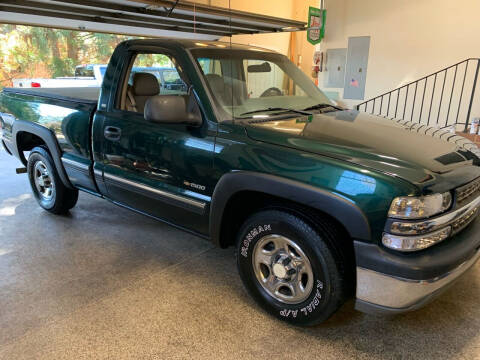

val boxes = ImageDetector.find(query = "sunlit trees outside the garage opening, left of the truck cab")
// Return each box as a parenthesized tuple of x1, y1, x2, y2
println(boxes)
(0, 24, 135, 88)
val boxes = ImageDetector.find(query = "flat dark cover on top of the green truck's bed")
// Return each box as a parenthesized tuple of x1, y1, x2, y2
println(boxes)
(3, 87, 100, 104)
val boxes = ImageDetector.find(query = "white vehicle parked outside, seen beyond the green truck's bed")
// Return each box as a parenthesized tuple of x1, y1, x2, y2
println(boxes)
(13, 64, 107, 88)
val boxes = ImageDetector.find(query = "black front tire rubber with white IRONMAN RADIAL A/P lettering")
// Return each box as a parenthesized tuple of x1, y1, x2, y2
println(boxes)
(237, 210, 348, 326)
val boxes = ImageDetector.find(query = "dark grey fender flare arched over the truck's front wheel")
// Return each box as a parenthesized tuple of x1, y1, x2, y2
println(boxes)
(210, 171, 371, 246)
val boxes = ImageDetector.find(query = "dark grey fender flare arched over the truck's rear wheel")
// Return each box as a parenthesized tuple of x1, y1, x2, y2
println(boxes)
(12, 120, 73, 189)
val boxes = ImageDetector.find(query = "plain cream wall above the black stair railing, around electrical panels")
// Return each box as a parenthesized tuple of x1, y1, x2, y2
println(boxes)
(319, 0, 480, 106)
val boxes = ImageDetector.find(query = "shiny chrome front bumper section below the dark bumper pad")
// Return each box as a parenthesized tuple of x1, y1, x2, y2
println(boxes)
(355, 249, 480, 313)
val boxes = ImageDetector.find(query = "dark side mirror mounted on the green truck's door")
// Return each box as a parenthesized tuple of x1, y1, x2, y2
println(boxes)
(143, 94, 202, 126)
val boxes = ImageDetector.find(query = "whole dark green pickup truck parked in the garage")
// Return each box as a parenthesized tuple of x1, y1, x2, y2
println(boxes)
(0, 39, 480, 325)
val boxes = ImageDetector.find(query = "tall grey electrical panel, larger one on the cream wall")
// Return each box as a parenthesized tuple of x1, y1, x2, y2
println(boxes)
(343, 36, 370, 100)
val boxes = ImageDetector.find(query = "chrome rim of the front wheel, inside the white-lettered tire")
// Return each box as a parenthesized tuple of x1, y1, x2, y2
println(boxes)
(252, 235, 314, 304)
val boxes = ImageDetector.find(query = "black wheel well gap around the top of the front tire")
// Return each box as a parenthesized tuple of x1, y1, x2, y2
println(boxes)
(220, 191, 356, 291)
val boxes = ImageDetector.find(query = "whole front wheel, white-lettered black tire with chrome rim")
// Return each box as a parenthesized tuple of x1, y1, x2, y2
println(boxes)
(237, 210, 345, 326)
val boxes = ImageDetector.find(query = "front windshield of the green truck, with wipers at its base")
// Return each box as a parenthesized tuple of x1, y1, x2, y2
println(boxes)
(192, 48, 332, 120)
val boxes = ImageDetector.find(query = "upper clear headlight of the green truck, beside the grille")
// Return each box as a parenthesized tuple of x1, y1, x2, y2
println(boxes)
(388, 192, 452, 219)
